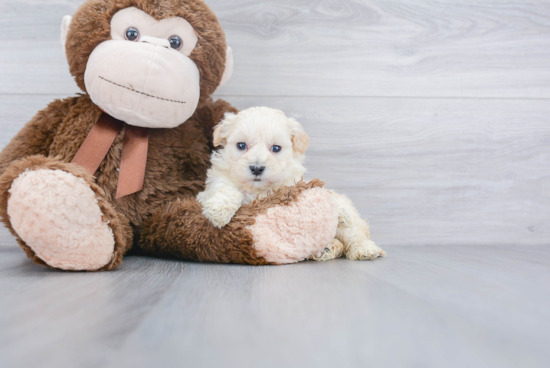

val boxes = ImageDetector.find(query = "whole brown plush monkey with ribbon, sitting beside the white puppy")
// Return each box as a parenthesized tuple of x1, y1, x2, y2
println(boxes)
(0, 0, 337, 271)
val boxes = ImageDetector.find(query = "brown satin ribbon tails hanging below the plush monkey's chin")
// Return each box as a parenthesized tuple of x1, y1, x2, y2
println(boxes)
(72, 113, 149, 199)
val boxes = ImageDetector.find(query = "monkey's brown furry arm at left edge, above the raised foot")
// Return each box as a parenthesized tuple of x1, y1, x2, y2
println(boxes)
(0, 97, 78, 175)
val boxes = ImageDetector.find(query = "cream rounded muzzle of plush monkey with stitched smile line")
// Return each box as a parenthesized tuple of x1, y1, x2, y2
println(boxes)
(84, 40, 200, 128)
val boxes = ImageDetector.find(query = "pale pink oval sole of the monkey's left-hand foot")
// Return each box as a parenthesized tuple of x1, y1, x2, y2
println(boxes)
(7, 169, 115, 271)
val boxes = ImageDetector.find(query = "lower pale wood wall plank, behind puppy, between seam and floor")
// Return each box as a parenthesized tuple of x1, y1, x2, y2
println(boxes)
(0, 96, 550, 246)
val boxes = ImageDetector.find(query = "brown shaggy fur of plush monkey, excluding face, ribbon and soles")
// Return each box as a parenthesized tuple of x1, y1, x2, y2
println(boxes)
(0, 0, 332, 270)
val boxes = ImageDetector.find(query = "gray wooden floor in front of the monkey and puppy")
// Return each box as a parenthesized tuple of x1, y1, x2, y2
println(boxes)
(0, 246, 550, 368)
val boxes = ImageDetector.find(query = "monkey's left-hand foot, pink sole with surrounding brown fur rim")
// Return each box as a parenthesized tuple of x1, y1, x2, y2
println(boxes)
(0, 156, 132, 271)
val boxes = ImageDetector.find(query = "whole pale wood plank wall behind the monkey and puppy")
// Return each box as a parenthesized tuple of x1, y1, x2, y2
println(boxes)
(0, 0, 550, 247)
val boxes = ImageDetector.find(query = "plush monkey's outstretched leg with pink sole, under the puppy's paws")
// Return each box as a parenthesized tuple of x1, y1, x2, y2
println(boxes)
(139, 181, 338, 265)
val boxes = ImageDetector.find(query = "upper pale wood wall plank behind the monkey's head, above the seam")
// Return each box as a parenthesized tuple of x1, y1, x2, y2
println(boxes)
(0, 0, 550, 98)
